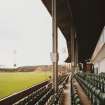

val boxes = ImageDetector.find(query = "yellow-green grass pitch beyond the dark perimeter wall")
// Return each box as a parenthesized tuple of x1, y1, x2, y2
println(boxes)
(0, 71, 51, 99)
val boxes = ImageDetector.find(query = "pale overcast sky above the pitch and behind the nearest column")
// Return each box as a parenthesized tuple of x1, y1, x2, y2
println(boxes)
(0, 0, 67, 67)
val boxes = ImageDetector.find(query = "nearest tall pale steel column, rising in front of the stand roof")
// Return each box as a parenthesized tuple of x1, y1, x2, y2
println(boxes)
(52, 0, 58, 93)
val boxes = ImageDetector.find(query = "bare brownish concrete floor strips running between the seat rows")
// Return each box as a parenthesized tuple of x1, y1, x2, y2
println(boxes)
(64, 74, 92, 105)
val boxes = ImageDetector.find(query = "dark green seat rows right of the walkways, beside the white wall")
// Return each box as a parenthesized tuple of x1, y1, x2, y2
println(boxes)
(75, 73, 105, 105)
